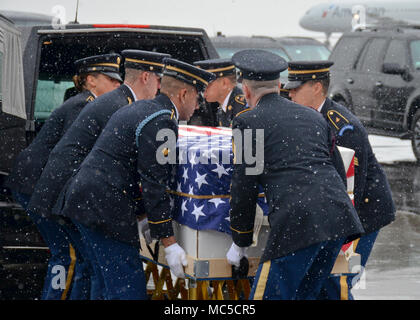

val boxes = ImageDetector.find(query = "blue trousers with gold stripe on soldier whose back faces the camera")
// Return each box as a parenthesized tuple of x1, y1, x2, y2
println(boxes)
(250, 238, 344, 300)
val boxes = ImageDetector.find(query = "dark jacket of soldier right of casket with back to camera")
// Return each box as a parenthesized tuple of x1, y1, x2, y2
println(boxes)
(230, 94, 363, 262)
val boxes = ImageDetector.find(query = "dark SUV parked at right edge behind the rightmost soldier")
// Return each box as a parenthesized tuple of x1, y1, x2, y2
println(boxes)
(329, 27, 420, 160)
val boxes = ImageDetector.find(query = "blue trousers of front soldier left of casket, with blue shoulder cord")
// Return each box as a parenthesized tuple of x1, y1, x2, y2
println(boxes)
(73, 221, 147, 300)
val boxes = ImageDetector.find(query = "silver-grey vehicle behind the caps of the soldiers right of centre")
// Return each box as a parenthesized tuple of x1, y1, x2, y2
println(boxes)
(210, 34, 330, 82)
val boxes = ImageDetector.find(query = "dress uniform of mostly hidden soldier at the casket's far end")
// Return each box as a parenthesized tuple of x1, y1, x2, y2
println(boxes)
(194, 59, 248, 127)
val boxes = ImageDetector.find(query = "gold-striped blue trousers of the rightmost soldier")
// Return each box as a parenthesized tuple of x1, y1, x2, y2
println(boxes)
(318, 231, 379, 300)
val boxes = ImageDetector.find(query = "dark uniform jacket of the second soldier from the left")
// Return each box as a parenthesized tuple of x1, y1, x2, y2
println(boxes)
(28, 85, 134, 216)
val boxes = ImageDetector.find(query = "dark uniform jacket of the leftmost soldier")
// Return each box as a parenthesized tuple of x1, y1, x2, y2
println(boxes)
(6, 91, 95, 195)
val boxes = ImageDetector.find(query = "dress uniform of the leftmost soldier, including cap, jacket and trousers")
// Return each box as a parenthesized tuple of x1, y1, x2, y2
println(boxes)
(7, 55, 122, 300)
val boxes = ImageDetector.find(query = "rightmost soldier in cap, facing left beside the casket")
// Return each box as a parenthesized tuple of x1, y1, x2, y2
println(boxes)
(286, 61, 395, 300)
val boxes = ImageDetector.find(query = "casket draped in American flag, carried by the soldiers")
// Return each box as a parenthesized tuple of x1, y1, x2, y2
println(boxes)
(140, 126, 360, 280)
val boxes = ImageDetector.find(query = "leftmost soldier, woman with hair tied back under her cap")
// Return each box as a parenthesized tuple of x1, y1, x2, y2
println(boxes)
(7, 54, 122, 300)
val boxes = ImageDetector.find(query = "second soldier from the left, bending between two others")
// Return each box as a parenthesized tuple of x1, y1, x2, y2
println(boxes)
(28, 50, 169, 299)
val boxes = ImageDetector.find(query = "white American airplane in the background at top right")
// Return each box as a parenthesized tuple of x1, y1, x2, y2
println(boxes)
(299, 0, 420, 41)
